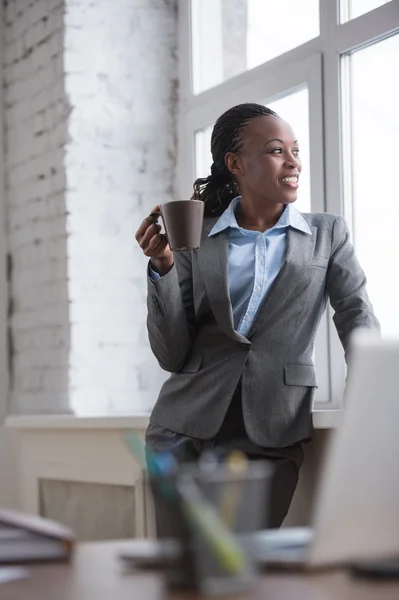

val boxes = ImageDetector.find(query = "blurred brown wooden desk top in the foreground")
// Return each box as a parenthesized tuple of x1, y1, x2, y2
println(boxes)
(0, 542, 399, 600)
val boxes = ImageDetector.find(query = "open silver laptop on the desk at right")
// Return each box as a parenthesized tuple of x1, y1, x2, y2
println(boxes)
(255, 330, 399, 568)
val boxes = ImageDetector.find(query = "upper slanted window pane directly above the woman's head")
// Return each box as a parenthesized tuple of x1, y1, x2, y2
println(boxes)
(191, 0, 319, 94)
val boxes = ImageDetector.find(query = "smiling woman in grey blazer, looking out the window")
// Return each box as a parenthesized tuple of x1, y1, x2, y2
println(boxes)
(136, 104, 379, 527)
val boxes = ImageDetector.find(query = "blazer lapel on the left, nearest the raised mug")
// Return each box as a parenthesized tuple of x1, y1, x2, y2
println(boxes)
(197, 218, 248, 342)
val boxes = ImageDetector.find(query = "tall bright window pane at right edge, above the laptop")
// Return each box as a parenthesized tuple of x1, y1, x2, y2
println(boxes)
(344, 35, 399, 335)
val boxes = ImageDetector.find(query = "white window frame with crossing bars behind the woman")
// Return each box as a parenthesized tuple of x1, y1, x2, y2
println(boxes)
(176, 0, 399, 409)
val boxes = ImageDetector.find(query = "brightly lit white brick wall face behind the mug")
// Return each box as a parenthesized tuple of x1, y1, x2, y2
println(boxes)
(65, 0, 176, 413)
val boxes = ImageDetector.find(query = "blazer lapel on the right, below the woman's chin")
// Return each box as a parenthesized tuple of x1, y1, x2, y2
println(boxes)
(248, 227, 316, 338)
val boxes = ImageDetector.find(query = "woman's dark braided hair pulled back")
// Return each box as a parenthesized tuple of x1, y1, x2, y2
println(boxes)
(192, 103, 277, 217)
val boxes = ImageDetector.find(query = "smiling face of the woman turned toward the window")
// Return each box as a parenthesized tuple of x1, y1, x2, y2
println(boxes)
(225, 116, 302, 204)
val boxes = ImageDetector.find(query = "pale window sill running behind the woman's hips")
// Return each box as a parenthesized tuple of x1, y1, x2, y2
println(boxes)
(5, 409, 344, 430)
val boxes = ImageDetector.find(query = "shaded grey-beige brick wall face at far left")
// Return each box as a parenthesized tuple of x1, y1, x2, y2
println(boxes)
(3, 0, 69, 412)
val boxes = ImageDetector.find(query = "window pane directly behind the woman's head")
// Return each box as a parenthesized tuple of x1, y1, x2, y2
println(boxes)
(195, 88, 311, 212)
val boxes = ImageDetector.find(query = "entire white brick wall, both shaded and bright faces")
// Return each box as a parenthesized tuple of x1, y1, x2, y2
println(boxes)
(1, 0, 177, 414)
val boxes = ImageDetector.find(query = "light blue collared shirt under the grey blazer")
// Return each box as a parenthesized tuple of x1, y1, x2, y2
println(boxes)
(209, 196, 311, 336)
